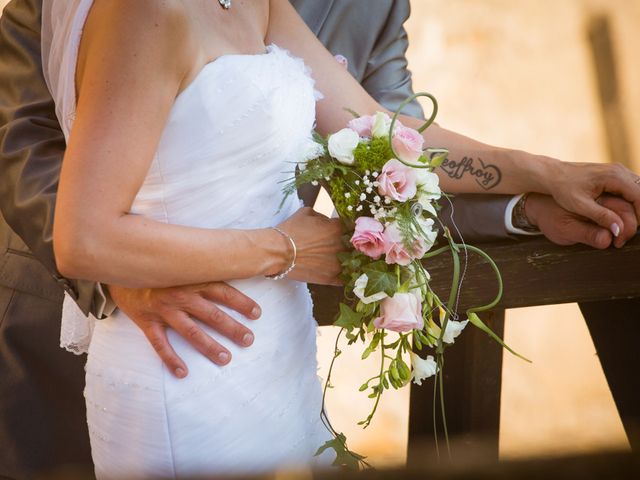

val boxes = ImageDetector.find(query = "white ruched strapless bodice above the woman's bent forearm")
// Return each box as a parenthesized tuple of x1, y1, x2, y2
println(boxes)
(132, 45, 315, 230)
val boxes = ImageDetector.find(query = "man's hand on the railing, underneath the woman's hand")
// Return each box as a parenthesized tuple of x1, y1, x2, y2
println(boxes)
(525, 193, 638, 249)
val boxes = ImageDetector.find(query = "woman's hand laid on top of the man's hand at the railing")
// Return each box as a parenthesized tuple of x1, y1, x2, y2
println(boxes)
(549, 162, 640, 237)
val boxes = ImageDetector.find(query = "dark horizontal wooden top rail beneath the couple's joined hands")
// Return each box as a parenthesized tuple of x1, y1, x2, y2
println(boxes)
(311, 235, 640, 325)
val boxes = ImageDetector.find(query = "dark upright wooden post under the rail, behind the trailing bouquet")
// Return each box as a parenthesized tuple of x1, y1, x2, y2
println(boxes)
(408, 310, 504, 466)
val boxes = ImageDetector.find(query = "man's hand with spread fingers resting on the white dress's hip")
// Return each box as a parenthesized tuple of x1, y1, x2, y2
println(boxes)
(108, 282, 261, 378)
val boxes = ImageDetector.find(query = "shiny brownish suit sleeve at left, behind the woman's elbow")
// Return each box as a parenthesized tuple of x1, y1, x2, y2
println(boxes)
(0, 0, 112, 318)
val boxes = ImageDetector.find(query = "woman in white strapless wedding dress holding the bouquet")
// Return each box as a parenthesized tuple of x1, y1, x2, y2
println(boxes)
(43, 0, 616, 478)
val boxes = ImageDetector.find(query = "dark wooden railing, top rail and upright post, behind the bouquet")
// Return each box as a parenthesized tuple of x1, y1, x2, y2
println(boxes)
(312, 235, 640, 464)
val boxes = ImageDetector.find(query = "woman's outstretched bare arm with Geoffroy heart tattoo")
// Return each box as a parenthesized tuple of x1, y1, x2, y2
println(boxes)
(267, 0, 640, 234)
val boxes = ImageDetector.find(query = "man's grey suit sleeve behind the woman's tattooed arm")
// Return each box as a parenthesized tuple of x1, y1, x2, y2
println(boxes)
(362, 0, 513, 242)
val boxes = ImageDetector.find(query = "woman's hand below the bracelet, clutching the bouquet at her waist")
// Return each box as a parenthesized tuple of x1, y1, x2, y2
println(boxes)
(272, 207, 346, 285)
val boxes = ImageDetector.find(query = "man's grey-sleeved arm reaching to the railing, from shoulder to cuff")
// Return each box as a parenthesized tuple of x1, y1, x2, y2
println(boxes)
(293, 0, 512, 241)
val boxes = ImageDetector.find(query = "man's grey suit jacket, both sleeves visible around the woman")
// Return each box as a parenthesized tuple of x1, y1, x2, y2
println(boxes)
(0, 0, 508, 322)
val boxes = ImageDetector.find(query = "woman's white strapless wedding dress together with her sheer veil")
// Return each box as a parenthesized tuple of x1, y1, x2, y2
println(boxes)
(43, 0, 329, 479)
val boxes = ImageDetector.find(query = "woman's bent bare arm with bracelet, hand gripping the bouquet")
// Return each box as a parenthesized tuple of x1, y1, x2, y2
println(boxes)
(54, 0, 340, 287)
